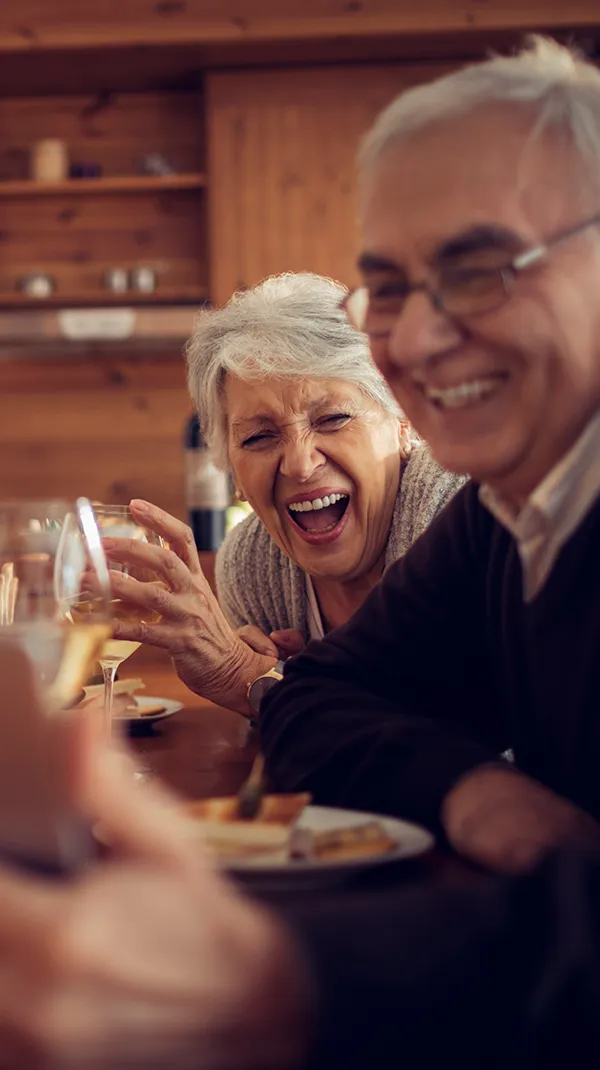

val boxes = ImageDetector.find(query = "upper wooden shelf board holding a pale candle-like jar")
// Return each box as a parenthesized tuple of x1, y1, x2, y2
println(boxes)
(0, 171, 206, 197)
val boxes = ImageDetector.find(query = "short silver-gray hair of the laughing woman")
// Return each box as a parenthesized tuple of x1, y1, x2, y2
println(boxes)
(185, 273, 402, 468)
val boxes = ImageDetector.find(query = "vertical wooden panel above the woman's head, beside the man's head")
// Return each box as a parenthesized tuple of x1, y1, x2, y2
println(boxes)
(206, 64, 450, 303)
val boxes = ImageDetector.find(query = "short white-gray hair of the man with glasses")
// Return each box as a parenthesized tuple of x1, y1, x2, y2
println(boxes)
(359, 35, 600, 182)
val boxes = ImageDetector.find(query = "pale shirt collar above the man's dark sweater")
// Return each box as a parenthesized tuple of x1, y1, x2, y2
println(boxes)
(479, 412, 600, 601)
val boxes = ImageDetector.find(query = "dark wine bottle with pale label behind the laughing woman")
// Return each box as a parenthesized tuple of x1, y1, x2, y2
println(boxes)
(184, 414, 231, 550)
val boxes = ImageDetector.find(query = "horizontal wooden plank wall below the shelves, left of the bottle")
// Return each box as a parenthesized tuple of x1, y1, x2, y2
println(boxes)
(0, 353, 189, 517)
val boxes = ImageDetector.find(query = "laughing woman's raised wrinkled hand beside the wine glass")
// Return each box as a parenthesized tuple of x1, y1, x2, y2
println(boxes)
(103, 500, 277, 715)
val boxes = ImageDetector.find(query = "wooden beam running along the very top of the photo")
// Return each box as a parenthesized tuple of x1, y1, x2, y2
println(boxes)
(0, 0, 600, 50)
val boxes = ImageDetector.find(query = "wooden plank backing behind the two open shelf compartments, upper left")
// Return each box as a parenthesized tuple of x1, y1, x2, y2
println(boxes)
(0, 92, 207, 304)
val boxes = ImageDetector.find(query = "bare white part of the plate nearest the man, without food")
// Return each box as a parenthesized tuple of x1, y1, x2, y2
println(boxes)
(222, 806, 434, 891)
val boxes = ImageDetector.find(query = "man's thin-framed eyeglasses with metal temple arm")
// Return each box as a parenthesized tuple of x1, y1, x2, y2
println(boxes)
(341, 215, 600, 337)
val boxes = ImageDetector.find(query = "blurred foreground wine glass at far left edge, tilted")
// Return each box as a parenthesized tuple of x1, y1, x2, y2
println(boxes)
(0, 499, 110, 713)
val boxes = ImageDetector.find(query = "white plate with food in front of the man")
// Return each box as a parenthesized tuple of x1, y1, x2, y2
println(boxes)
(177, 794, 433, 891)
